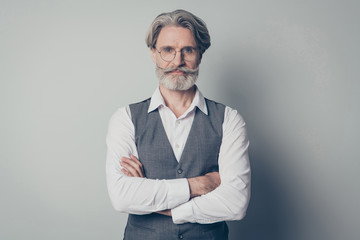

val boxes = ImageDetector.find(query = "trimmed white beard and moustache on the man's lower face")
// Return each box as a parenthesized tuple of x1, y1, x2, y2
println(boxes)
(156, 66, 199, 91)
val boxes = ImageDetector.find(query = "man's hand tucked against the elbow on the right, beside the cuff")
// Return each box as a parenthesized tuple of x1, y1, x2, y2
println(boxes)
(187, 172, 221, 198)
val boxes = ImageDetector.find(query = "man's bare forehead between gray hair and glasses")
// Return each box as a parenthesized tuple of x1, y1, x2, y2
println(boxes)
(156, 26, 196, 48)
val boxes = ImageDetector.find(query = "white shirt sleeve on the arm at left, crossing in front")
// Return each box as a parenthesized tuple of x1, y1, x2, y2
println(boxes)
(106, 106, 190, 214)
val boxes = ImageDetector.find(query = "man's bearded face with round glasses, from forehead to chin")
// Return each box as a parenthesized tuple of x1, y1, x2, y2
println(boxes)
(151, 26, 200, 90)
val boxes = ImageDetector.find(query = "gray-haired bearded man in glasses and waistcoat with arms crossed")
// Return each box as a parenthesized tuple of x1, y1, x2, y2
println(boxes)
(106, 10, 250, 240)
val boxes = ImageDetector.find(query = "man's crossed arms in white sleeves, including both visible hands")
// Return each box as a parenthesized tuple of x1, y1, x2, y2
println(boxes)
(106, 107, 250, 223)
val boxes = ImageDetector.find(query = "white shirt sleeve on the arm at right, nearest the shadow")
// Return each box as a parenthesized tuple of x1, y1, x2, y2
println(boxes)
(171, 107, 251, 224)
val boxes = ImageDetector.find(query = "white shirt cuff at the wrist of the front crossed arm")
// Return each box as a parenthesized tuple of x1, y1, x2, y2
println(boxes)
(166, 178, 190, 209)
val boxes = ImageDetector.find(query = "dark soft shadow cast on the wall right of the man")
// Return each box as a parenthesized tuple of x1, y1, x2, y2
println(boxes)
(216, 57, 296, 240)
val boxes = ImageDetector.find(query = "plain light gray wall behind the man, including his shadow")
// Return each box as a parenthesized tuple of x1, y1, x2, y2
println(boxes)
(0, 0, 360, 240)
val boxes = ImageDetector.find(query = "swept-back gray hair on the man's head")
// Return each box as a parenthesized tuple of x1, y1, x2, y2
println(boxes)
(145, 9, 210, 55)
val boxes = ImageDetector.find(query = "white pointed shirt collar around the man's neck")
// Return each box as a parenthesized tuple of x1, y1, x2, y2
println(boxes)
(148, 86, 208, 115)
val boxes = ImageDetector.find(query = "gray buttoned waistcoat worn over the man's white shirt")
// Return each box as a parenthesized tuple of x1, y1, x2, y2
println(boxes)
(124, 99, 228, 240)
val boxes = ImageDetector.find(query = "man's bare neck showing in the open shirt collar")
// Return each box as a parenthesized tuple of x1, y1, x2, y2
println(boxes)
(159, 84, 196, 118)
